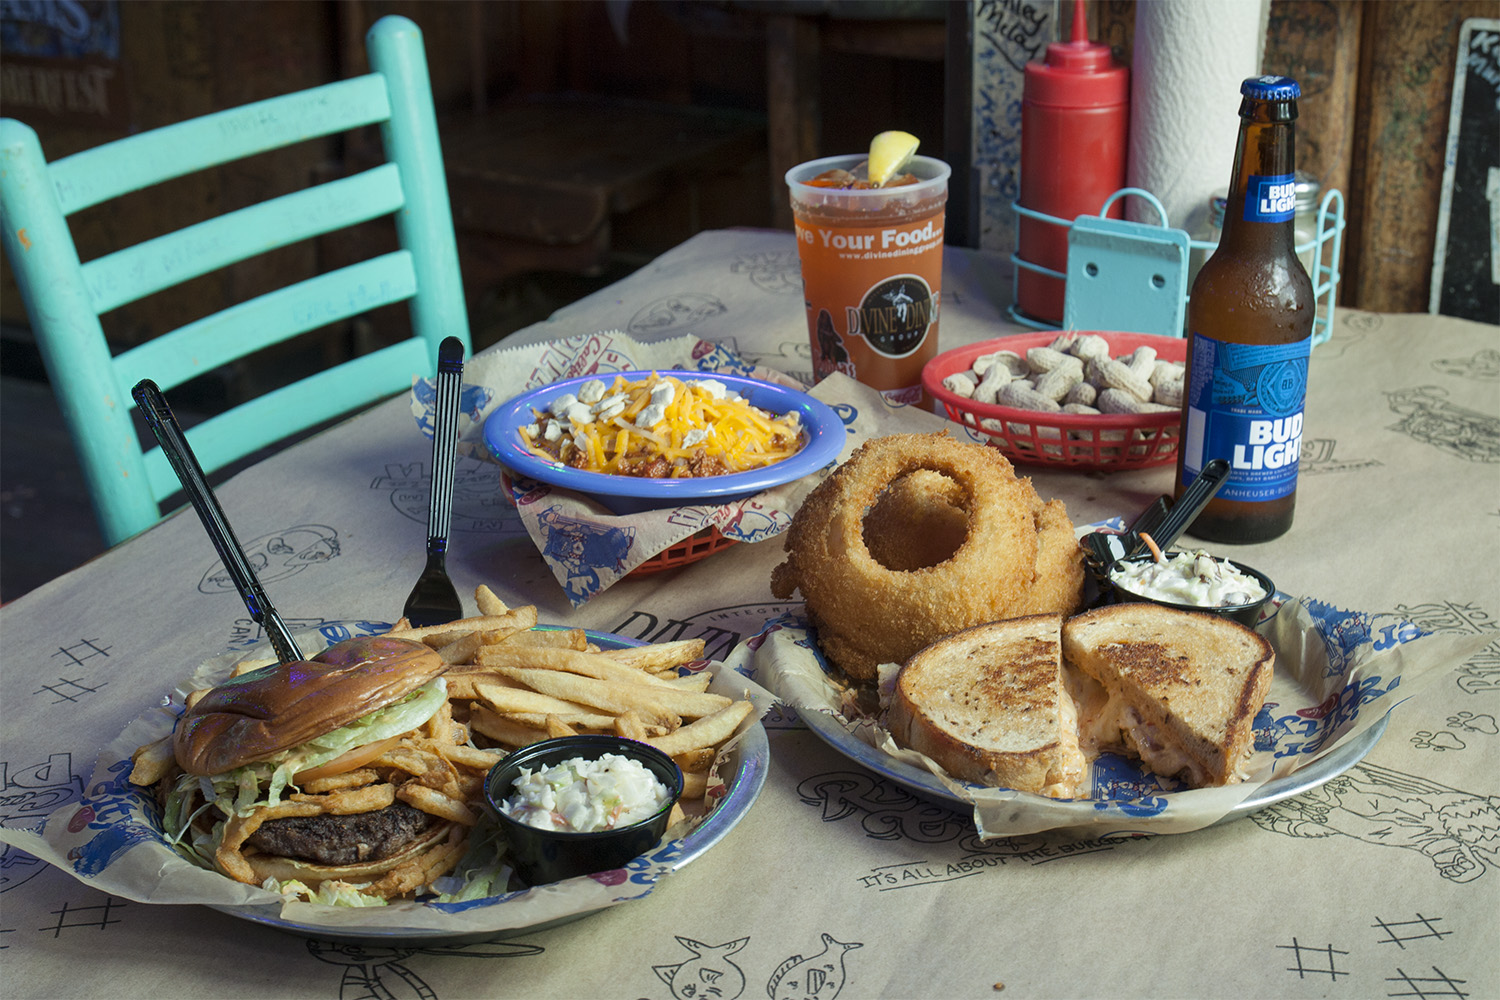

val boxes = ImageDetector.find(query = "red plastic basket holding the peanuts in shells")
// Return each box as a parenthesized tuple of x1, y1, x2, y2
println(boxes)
(923, 330, 1188, 471)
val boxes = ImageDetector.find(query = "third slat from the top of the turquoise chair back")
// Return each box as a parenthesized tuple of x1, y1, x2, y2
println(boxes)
(114, 250, 417, 389)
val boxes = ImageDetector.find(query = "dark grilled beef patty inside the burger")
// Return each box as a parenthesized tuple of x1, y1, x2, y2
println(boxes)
(246, 802, 437, 865)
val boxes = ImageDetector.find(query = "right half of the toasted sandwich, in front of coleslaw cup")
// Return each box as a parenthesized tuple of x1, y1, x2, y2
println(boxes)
(1062, 603, 1275, 787)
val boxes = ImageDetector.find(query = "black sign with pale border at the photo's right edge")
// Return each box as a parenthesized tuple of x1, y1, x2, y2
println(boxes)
(1428, 18, 1500, 324)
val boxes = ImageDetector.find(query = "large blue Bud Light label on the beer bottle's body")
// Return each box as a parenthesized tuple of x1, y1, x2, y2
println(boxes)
(1182, 333, 1313, 502)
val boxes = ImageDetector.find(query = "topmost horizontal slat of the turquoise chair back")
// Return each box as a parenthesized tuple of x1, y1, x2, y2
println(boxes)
(53, 73, 390, 216)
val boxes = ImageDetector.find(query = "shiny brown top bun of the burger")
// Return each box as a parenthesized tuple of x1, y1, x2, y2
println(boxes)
(173, 636, 447, 775)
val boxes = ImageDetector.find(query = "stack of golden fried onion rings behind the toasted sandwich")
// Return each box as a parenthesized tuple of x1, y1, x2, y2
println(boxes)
(771, 433, 1083, 682)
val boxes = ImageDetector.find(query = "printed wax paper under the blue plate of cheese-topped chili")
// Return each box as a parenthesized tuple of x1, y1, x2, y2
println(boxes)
(411, 330, 827, 607)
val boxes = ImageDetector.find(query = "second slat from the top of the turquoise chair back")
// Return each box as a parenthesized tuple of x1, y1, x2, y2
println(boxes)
(83, 163, 405, 315)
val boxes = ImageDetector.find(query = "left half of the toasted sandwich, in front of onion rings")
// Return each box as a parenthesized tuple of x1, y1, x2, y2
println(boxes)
(887, 615, 1086, 798)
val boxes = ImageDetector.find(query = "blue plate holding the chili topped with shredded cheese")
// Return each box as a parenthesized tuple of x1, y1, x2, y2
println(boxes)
(485, 370, 846, 514)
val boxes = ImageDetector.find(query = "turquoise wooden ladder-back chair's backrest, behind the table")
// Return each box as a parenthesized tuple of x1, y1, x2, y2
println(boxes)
(0, 16, 470, 544)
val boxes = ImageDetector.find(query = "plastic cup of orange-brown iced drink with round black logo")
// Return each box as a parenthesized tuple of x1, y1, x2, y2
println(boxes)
(786, 156, 953, 403)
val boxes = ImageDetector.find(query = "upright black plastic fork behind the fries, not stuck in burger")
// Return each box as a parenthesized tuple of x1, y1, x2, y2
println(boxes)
(402, 337, 464, 628)
